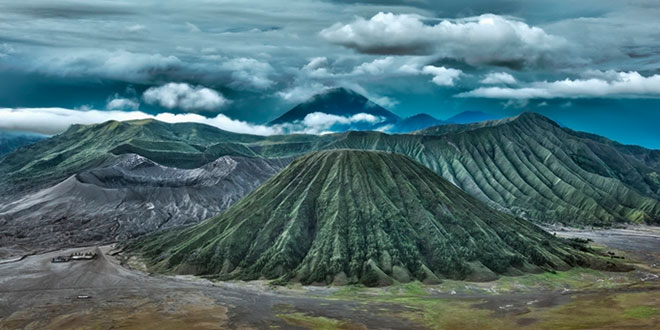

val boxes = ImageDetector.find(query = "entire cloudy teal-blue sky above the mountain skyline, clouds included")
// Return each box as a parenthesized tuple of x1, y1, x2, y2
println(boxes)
(0, 0, 660, 149)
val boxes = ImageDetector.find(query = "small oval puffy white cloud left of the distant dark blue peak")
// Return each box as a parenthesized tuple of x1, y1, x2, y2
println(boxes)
(142, 83, 229, 111)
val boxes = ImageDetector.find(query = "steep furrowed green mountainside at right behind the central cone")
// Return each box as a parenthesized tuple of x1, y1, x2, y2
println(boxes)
(408, 113, 660, 223)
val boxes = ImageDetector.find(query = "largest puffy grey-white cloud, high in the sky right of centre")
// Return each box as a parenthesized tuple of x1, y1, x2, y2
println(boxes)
(321, 12, 567, 66)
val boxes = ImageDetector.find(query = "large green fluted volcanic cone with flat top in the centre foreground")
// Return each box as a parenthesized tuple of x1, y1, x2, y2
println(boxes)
(130, 150, 608, 285)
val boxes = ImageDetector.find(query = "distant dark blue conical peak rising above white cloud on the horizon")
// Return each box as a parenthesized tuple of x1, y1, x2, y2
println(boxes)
(270, 87, 401, 129)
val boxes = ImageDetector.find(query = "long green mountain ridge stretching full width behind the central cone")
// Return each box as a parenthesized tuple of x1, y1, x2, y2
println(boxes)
(0, 113, 660, 225)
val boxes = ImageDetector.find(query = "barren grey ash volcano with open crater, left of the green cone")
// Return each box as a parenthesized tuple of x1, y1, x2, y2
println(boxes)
(0, 154, 289, 254)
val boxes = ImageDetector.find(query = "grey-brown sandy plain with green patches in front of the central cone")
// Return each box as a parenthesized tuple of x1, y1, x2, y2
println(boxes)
(0, 228, 660, 330)
